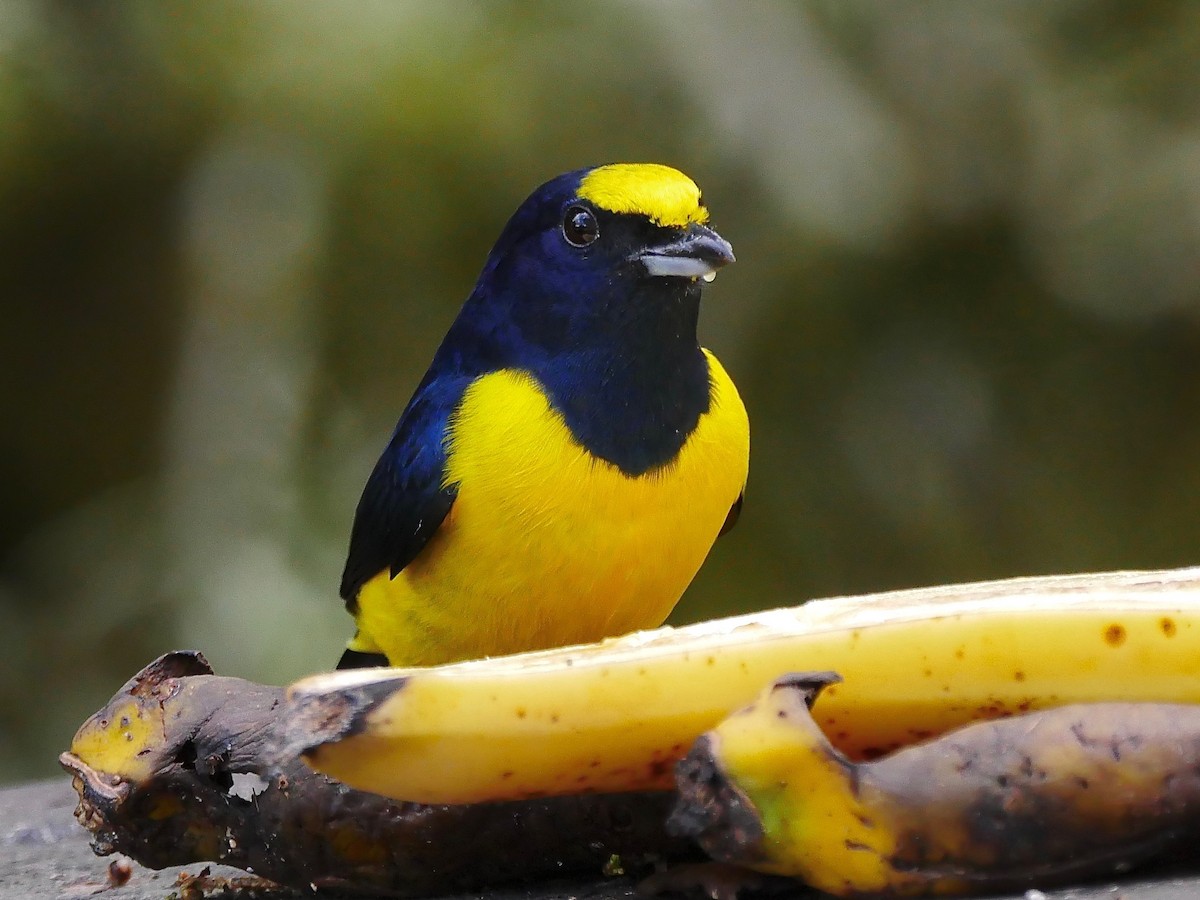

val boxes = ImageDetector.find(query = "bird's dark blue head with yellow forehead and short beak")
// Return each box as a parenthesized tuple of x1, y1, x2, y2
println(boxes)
(468, 163, 733, 353)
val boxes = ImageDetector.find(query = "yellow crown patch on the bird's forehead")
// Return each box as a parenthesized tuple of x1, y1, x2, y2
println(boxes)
(580, 162, 708, 228)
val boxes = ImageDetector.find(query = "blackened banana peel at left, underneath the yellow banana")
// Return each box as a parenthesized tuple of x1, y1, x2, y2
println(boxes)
(61, 653, 697, 896)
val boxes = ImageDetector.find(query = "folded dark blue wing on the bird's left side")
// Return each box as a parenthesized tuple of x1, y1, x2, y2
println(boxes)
(341, 378, 470, 612)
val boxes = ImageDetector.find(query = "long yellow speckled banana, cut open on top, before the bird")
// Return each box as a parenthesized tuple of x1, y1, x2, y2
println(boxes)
(286, 569, 1200, 803)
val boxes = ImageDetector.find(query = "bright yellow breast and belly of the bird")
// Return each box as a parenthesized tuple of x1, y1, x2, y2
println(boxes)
(358, 350, 750, 665)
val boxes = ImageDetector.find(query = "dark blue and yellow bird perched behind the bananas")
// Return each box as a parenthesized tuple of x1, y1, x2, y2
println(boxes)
(338, 163, 750, 668)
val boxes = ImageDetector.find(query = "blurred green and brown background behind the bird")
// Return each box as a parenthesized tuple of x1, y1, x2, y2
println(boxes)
(0, 0, 1200, 780)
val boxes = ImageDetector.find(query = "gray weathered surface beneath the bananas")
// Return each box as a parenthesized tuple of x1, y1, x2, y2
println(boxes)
(7, 779, 1200, 900)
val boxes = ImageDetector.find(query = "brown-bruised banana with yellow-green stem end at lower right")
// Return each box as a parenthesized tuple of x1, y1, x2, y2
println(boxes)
(667, 672, 1200, 896)
